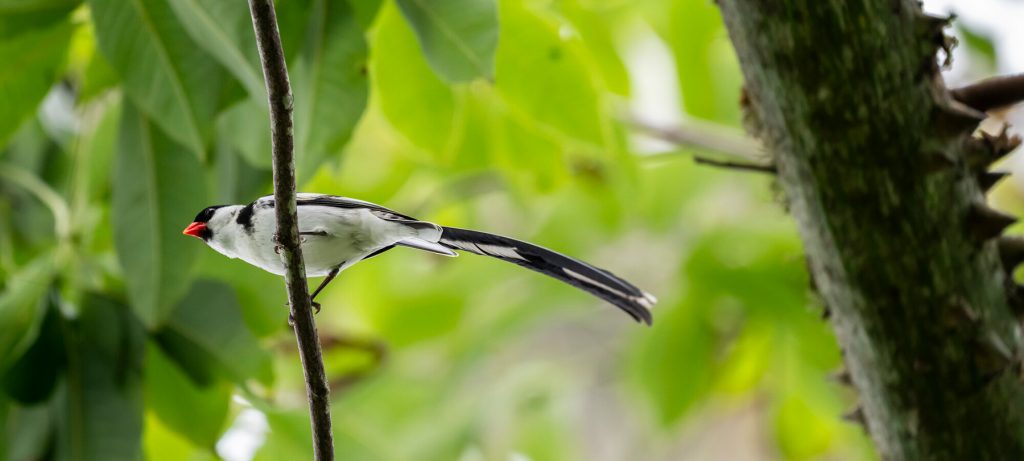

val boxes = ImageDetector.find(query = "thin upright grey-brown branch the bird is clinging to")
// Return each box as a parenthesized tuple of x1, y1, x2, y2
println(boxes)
(249, 0, 334, 461)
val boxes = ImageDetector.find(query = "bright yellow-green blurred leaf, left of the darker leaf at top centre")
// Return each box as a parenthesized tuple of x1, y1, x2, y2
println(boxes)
(373, 3, 456, 156)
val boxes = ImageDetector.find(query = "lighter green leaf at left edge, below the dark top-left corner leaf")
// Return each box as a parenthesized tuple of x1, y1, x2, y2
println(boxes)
(0, 22, 72, 145)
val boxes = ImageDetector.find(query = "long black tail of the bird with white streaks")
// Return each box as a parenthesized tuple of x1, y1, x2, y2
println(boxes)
(438, 227, 657, 325)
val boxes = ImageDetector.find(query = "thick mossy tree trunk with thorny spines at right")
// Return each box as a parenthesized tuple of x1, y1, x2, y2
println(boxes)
(719, 0, 1024, 460)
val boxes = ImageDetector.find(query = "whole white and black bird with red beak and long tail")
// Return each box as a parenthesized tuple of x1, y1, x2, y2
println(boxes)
(182, 194, 656, 325)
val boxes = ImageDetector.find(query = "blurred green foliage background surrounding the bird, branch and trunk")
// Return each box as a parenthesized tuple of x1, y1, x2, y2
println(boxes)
(0, 0, 1024, 461)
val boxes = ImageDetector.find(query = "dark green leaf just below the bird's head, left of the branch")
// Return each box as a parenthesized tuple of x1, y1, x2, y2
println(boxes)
(160, 280, 272, 383)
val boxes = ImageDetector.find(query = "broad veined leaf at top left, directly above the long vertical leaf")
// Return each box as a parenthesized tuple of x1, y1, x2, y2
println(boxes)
(89, 0, 225, 160)
